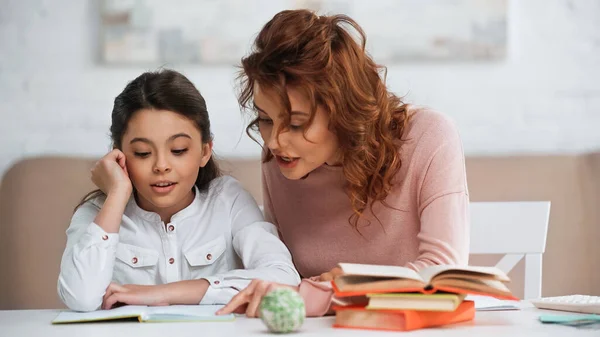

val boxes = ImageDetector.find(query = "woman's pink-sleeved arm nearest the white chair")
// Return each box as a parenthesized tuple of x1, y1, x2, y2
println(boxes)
(406, 117, 470, 270)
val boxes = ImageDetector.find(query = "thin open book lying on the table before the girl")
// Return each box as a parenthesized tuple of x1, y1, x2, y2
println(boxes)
(52, 305, 235, 324)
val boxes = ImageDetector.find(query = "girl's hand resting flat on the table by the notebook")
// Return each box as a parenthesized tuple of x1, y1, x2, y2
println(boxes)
(102, 282, 169, 310)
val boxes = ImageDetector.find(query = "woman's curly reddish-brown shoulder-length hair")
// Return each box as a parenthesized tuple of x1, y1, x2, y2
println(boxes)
(238, 10, 408, 228)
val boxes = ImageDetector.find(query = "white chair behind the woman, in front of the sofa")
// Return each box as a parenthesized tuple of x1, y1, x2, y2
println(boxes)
(470, 201, 550, 299)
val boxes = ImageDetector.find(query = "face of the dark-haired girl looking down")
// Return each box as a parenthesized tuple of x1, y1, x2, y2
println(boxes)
(122, 109, 212, 220)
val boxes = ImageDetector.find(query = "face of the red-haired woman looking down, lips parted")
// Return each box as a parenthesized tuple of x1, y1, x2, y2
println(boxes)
(254, 84, 339, 179)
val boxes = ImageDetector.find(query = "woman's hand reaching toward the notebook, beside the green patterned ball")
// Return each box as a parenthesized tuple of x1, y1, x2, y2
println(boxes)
(217, 280, 298, 317)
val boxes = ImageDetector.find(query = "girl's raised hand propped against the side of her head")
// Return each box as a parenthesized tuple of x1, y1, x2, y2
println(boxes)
(92, 149, 133, 199)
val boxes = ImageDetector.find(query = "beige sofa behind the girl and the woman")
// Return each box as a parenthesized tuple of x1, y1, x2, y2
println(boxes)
(0, 153, 600, 309)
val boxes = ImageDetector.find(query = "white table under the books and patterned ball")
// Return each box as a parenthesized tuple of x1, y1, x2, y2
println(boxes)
(0, 307, 600, 337)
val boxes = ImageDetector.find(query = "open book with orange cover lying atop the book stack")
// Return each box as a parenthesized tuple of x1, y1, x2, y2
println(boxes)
(332, 263, 517, 300)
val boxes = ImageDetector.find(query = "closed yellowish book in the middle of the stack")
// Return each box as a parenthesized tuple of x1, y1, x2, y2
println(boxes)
(366, 293, 465, 311)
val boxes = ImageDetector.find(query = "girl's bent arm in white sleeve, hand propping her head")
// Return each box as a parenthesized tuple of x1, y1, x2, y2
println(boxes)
(57, 150, 132, 311)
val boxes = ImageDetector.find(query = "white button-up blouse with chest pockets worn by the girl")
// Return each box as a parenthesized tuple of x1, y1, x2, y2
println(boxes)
(58, 176, 300, 311)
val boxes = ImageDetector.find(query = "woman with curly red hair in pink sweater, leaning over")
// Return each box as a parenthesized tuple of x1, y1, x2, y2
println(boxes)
(222, 10, 469, 316)
